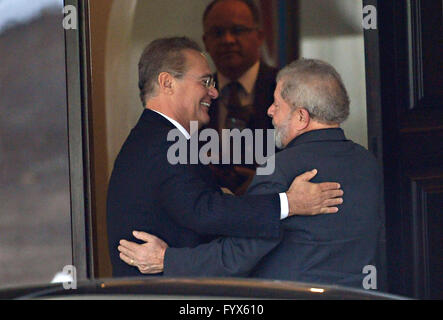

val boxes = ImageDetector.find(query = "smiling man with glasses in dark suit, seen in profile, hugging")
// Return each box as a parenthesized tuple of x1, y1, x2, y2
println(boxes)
(107, 38, 342, 276)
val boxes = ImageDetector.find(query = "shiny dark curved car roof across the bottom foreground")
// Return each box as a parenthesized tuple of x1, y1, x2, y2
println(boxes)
(0, 278, 407, 300)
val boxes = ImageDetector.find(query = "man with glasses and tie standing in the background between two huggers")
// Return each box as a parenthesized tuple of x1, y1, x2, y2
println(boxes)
(203, 0, 277, 194)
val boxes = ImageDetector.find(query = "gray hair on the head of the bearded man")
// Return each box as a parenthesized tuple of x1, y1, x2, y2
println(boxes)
(277, 59, 350, 124)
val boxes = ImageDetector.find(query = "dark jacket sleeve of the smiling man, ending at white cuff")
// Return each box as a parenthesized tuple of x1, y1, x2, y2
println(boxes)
(153, 144, 281, 238)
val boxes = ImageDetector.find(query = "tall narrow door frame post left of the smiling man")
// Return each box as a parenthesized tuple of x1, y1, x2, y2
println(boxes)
(64, 0, 95, 280)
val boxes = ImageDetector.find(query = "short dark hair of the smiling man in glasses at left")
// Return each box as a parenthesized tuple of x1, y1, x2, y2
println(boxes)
(138, 37, 203, 106)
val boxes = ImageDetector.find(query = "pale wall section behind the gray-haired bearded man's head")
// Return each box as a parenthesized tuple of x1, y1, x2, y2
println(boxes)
(300, 0, 368, 148)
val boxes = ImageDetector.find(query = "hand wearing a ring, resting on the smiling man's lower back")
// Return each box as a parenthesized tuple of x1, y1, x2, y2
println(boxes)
(118, 231, 168, 274)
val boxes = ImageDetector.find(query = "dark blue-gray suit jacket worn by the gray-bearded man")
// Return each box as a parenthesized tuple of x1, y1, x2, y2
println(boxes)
(164, 129, 382, 287)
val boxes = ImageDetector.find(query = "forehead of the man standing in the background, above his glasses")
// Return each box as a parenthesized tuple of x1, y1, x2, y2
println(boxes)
(204, 0, 254, 28)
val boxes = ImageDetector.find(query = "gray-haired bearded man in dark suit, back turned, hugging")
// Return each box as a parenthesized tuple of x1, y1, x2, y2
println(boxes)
(119, 60, 382, 287)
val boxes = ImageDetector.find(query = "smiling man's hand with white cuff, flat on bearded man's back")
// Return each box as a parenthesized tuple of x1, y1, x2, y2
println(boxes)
(286, 169, 343, 216)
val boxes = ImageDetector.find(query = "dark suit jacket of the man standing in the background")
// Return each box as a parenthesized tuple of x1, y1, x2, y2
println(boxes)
(207, 61, 278, 191)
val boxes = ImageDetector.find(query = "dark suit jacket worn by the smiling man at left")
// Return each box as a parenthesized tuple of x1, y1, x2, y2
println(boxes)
(107, 109, 280, 276)
